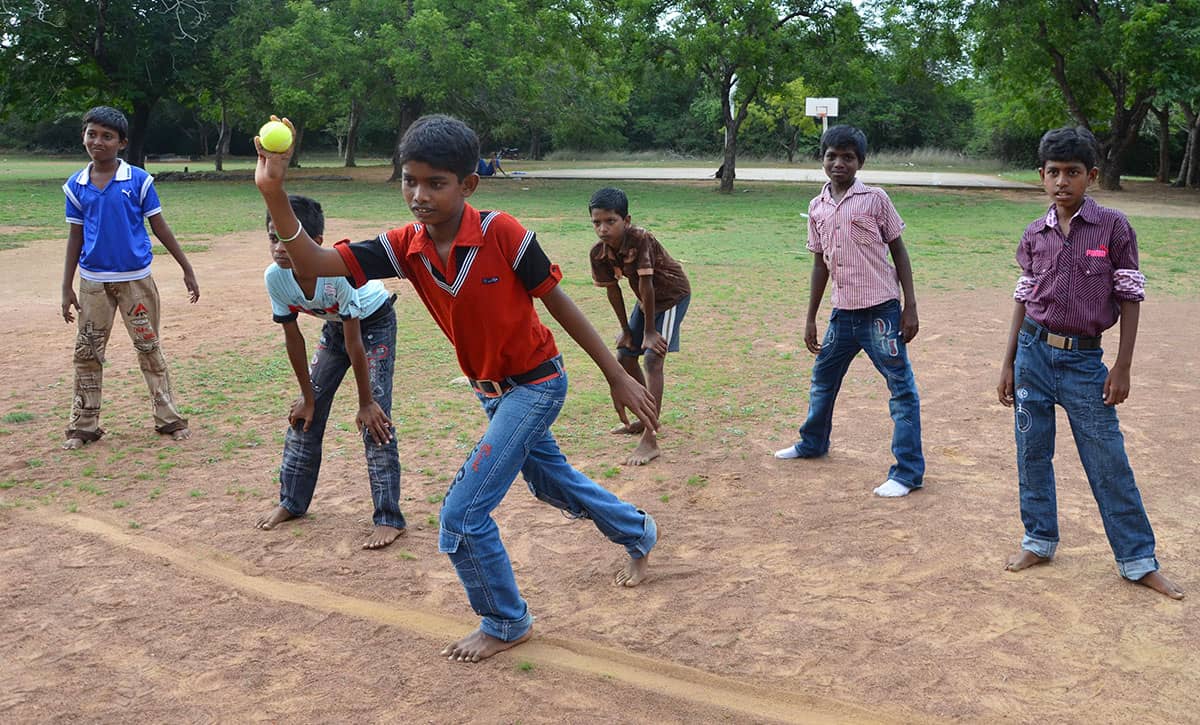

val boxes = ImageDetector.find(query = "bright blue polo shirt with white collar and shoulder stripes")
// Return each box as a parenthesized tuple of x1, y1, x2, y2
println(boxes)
(62, 158, 162, 282)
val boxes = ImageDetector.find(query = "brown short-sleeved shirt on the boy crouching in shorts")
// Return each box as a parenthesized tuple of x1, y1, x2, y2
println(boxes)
(589, 227, 691, 313)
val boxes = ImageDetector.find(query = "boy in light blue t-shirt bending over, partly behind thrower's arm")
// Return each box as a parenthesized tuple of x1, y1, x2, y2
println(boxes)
(254, 196, 404, 549)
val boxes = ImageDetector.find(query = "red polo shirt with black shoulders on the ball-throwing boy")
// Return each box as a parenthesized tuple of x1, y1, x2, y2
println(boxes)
(334, 204, 563, 381)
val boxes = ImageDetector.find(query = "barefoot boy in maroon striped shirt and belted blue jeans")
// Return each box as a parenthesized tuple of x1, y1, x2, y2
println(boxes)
(996, 127, 1183, 599)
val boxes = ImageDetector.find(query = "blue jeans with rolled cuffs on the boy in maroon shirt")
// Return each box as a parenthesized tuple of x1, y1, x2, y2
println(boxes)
(1013, 325, 1158, 580)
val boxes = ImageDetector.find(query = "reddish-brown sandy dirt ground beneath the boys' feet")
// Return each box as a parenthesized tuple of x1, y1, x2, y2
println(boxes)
(0, 178, 1200, 723)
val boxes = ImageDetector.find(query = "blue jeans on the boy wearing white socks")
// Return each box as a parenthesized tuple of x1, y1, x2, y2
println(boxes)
(796, 300, 925, 489)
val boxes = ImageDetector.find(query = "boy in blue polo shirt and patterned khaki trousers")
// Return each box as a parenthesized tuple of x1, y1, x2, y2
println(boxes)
(62, 106, 200, 450)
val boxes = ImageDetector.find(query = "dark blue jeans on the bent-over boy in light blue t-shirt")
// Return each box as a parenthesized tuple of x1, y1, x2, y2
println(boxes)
(280, 304, 404, 528)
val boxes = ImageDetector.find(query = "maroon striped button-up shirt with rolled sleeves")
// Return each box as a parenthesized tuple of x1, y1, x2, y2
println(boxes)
(1013, 197, 1146, 337)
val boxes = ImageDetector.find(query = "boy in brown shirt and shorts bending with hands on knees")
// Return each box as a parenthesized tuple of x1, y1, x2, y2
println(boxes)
(588, 186, 691, 466)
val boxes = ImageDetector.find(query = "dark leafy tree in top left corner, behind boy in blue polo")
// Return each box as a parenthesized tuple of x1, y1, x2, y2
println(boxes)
(0, 0, 235, 166)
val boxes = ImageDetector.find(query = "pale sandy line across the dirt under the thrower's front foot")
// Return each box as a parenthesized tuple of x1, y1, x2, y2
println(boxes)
(20, 510, 911, 723)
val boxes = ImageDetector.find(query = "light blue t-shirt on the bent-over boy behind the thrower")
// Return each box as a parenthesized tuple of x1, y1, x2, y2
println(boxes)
(263, 263, 391, 323)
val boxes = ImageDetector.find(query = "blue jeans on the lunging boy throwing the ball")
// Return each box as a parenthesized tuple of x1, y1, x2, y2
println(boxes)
(438, 358, 658, 642)
